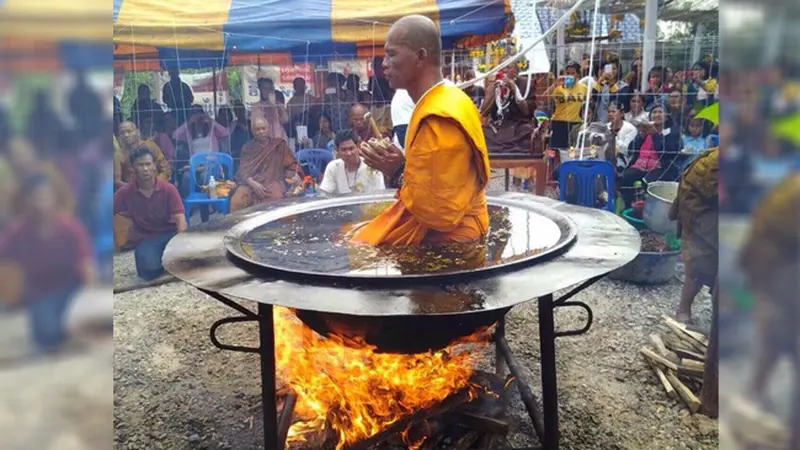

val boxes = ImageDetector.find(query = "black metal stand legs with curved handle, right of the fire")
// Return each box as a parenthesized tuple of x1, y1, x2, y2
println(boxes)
(494, 277, 601, 450)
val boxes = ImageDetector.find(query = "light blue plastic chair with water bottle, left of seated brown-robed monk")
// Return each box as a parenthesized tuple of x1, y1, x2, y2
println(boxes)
(183, 152, 233, 224)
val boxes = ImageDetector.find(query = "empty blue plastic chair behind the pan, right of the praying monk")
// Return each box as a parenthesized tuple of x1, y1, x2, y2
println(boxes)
(558, 160, 616, 212)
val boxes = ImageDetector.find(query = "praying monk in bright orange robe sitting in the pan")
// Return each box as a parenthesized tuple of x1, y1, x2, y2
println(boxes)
(354, 15, 490, 246)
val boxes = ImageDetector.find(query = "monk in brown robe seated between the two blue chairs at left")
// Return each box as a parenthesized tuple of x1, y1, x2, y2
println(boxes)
(231, 118, 302, 212)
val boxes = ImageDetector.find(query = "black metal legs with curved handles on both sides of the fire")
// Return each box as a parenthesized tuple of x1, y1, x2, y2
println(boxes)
(201, 277, 601, 450)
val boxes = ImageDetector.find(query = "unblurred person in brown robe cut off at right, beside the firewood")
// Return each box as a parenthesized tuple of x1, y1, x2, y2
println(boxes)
(669, 148, 719, 323)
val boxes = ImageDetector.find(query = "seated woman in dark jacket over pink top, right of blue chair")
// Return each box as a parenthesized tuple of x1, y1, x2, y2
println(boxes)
(619, 103, 681, 206)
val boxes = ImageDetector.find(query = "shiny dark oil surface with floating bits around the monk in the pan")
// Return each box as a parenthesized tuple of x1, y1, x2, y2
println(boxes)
(234, 202, 561, 277)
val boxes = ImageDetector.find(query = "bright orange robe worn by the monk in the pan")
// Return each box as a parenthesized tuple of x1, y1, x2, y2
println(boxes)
(354, 84, 490, 245)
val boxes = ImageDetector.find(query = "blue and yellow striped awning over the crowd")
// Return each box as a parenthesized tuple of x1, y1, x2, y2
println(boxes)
(112, 0, 513, 57)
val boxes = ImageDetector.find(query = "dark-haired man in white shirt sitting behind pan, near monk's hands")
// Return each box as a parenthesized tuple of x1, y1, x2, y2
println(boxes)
(319, 130, 385, 195)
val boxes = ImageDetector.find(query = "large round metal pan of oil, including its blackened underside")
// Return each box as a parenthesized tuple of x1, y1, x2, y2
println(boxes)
(224, 196, 577, 353)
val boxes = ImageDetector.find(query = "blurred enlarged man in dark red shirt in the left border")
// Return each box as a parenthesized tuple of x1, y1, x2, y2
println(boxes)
(0, 173, 94, 352)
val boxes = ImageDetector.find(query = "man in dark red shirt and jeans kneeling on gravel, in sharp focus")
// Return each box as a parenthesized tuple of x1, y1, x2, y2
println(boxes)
(114, 147, 186, 281)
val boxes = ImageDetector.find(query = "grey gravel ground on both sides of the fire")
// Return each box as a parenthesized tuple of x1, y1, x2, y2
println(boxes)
(114, 174, 718, 450)
